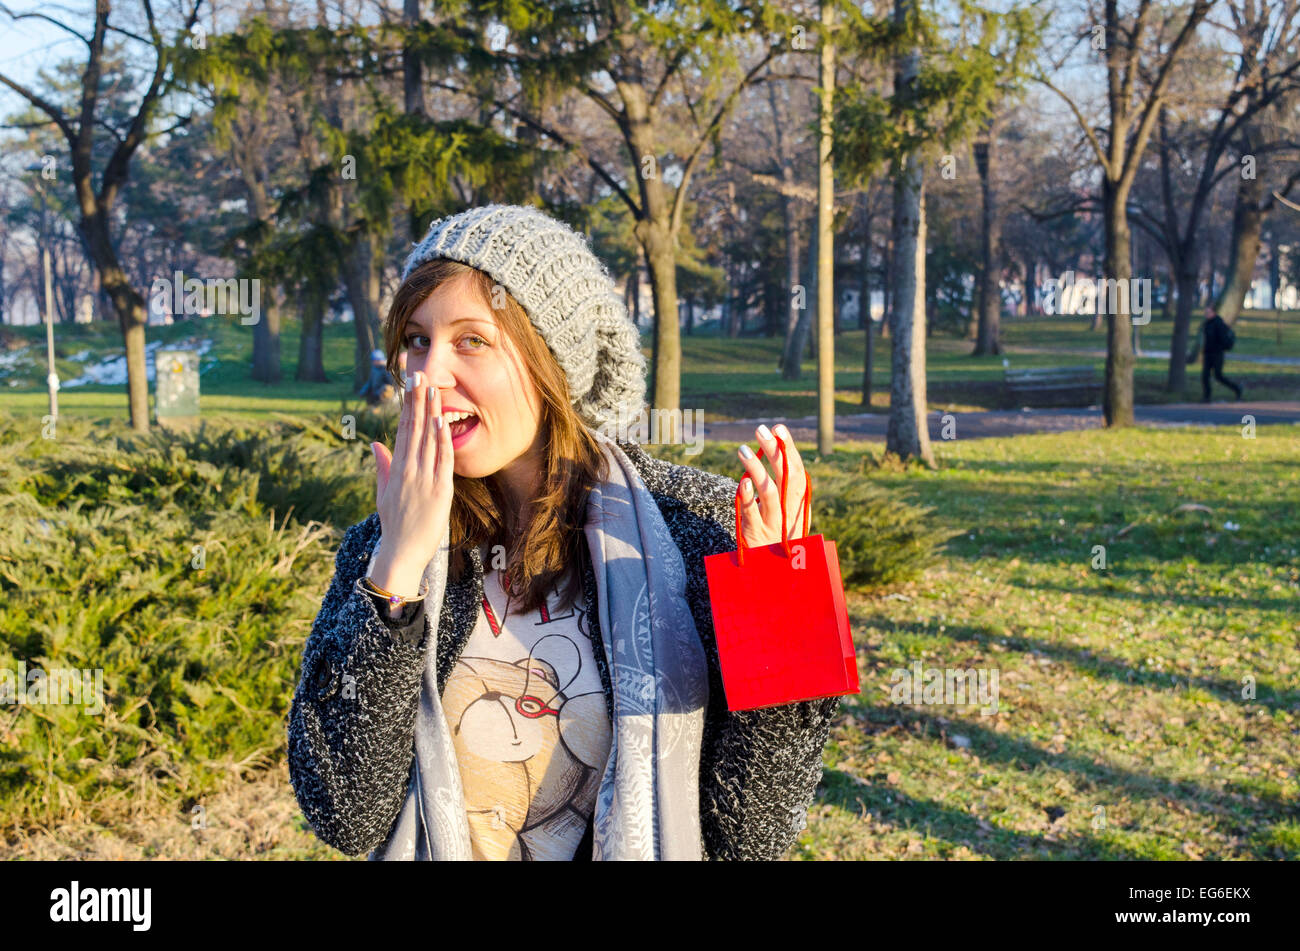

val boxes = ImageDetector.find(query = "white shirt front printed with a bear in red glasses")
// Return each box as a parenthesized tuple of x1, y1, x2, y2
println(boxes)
(442, 571, 611, 861)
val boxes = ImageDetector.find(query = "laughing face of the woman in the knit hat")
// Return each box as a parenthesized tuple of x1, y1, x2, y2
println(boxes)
(403, 274, 541, 487)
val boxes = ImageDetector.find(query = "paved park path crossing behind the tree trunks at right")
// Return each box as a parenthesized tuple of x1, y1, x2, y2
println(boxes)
(703, 400, 1300, 442)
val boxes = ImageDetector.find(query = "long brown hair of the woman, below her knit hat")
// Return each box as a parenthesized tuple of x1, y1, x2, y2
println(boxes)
(384, 257, 608, 612)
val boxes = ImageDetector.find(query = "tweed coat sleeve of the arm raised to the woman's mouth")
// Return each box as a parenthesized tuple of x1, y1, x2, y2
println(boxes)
(289, 514, 429, 855)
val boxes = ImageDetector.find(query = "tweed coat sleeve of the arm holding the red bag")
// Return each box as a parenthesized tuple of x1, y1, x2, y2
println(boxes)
(637, 449, 840, 860)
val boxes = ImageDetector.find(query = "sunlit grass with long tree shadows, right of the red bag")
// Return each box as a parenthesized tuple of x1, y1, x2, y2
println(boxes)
(780, 426, 1300, 859)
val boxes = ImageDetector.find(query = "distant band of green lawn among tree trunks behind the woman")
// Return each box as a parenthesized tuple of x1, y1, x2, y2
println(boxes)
(0, 312, 1300, 420)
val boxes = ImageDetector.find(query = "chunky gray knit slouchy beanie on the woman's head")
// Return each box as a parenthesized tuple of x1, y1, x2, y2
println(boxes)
(402, 204, 646, 435)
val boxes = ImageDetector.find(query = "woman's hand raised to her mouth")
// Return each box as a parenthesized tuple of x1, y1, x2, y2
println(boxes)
(371, 370, 455, 595)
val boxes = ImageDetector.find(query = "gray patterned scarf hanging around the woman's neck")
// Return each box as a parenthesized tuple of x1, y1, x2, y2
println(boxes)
(369, 429, 709, 861)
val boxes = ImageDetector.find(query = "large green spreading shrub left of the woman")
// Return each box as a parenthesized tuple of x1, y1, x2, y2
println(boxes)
(0, 421, 361, 826)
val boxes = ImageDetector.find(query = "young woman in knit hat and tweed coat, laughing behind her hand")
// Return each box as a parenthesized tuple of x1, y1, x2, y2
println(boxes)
(289, 205, 839, 860)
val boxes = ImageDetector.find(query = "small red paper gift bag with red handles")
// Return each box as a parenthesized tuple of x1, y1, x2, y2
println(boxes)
(705, 442, 859, 711)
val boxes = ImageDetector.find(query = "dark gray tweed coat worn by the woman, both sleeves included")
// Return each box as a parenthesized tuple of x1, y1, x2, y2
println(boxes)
(289, 443, 839, 860)
